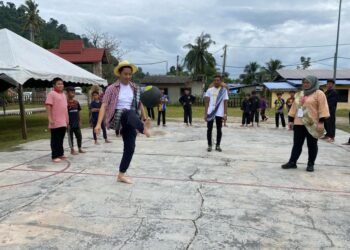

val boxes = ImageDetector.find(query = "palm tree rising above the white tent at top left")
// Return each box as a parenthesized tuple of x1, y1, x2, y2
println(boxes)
(23, 0, 43, 42)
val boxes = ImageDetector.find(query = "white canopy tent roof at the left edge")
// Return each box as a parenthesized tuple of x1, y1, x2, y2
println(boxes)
(0, 29, 107, 85)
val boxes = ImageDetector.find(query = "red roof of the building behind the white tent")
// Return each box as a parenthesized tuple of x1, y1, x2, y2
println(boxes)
(49, 40, 108, 63)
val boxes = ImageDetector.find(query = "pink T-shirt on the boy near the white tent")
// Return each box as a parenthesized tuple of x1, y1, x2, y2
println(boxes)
(45, 90, 69, 128)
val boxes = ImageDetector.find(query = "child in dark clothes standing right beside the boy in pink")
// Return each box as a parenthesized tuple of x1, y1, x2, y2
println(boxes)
(67, 87, 85, 155)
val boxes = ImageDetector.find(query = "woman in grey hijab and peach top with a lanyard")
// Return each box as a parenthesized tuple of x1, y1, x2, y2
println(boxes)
(282, 76, 329, 172)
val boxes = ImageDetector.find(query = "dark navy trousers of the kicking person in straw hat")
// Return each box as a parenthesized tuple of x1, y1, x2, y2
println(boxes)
(119, 110, 144, 173)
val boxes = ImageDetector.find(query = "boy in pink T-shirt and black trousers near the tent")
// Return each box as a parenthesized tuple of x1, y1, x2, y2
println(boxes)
(45, 78, 69, 163)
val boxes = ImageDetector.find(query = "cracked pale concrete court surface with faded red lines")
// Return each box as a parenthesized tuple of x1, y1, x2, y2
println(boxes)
(0, 122, 350, 250)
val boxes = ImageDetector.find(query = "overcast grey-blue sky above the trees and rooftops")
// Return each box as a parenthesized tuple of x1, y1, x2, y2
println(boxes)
(8, 0, 350, 77)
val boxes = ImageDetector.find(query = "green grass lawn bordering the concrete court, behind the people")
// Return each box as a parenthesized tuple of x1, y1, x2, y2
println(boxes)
(0, 105, 350, 150)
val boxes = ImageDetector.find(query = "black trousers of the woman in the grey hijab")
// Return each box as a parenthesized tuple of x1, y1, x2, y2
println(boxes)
(289, 125, 318, 165)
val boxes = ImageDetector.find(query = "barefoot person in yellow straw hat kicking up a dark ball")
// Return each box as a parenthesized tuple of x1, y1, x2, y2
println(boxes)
(95, 61, 150, 184)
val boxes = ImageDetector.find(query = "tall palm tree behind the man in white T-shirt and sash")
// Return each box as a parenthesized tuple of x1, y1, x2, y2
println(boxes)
(184, 33, 216, 76)
